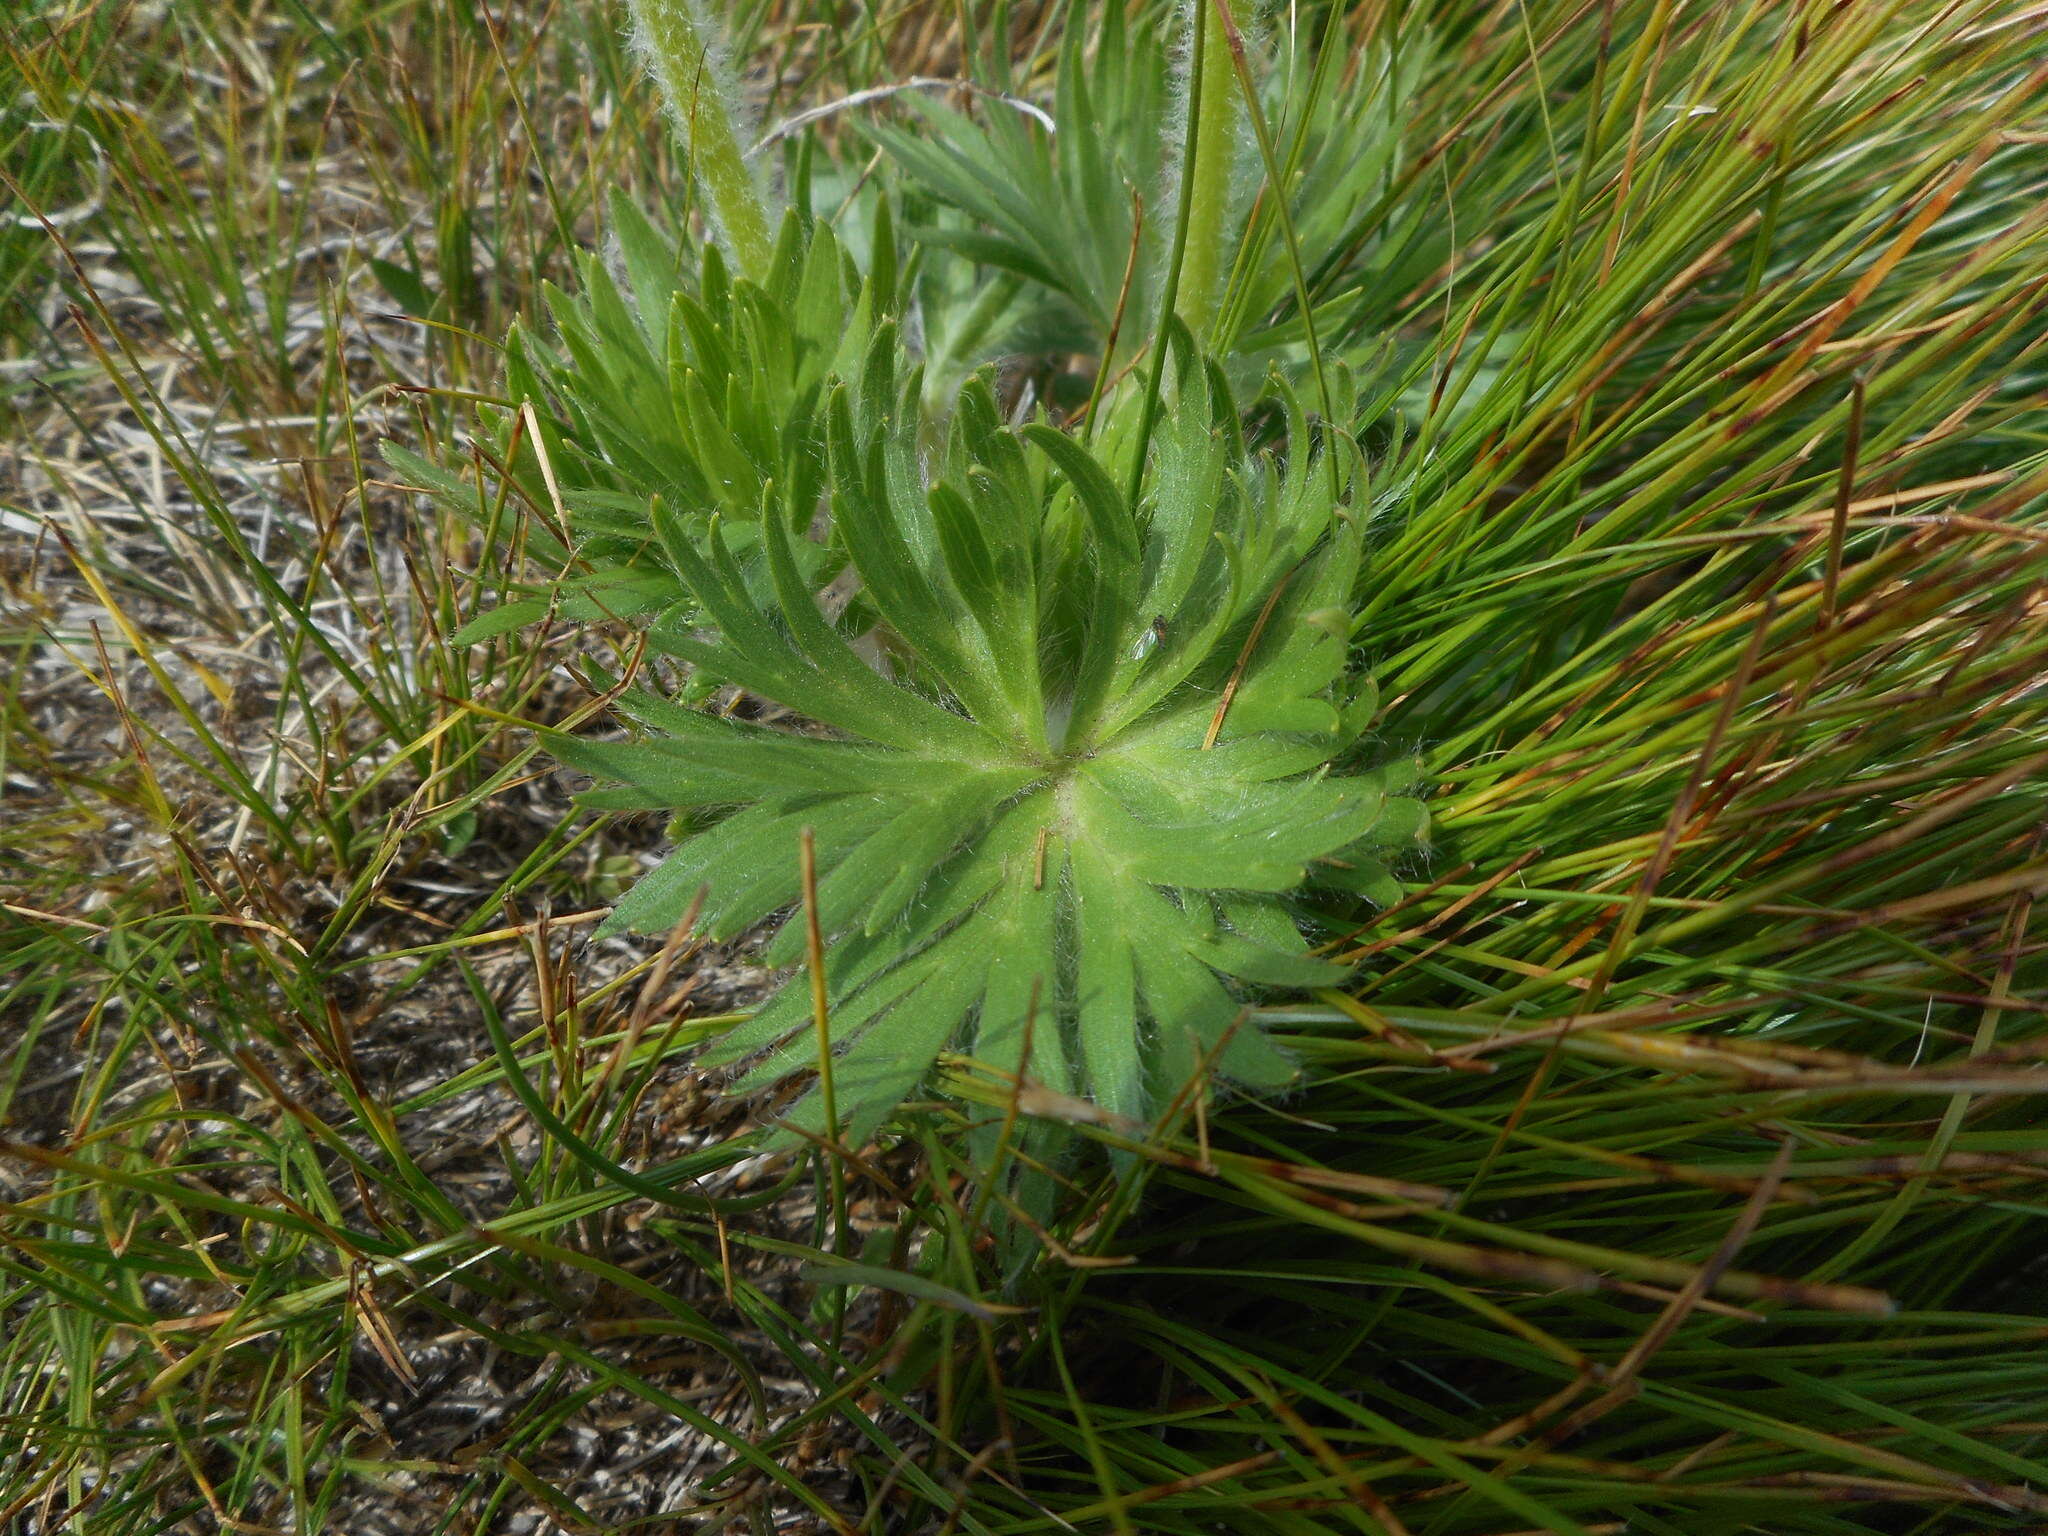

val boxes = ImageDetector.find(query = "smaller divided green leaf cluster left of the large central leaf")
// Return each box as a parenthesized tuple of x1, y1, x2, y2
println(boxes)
(385, 199, 897, 643)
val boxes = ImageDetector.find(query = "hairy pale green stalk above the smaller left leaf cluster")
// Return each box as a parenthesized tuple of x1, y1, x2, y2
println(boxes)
(627, 0, 774, 281)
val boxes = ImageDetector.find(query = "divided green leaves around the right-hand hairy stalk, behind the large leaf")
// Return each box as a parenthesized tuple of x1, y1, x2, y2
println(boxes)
(868, 0, 1448, 372)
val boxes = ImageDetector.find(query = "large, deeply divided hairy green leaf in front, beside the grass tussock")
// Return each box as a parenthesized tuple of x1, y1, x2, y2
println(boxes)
(559, 346, 1421, 1141)
